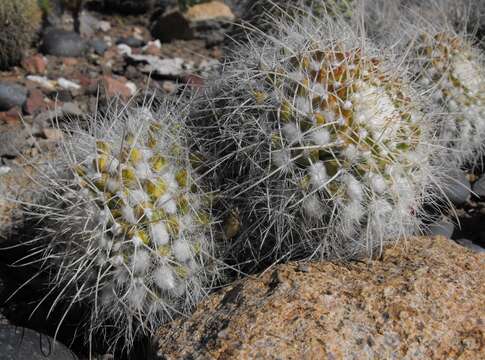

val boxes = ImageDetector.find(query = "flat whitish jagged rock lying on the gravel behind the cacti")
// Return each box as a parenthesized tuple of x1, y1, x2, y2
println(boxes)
(127, 54, 185, 77)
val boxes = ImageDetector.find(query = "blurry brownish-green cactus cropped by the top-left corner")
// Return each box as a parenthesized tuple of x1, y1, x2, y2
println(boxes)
(0, 0, 42, 70)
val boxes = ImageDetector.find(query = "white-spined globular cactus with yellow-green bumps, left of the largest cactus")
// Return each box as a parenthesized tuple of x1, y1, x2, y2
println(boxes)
(32, 97, 218, 348)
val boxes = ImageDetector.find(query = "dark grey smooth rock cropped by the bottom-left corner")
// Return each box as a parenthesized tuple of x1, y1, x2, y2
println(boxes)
(0, 325, 77, 360)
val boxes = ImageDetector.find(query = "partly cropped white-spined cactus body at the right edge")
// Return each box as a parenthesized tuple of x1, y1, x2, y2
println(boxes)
(416, 32, 485, 163)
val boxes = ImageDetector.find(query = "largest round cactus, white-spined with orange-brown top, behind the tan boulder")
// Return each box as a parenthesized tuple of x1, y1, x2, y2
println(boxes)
(195, 9, 436, 270)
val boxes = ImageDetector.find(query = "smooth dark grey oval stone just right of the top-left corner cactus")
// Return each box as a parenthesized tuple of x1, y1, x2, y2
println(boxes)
(41, 28, 86, 57)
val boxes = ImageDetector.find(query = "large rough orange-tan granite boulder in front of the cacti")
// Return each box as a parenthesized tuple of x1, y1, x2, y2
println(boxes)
(158, 237, 485, 359)
